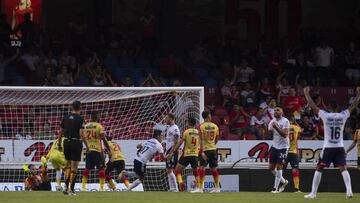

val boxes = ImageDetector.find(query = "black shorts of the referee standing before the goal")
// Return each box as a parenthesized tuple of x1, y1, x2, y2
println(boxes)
(64, 139, 82, 161)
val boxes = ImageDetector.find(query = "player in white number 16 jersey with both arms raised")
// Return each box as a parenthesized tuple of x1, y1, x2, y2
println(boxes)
(304, 87, 360, 199)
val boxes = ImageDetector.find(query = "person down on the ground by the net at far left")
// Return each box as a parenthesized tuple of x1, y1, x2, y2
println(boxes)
(22, 157, 51, 191)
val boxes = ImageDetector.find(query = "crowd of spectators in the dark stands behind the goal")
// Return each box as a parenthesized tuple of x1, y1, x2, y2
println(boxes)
(0, 3, 360, 140)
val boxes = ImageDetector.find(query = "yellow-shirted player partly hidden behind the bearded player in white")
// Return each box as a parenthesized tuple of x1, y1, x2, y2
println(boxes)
(284, 115, 301, 192)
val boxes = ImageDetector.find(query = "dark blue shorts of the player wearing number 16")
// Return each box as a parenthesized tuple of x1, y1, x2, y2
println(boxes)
(319, 147, 346, 167)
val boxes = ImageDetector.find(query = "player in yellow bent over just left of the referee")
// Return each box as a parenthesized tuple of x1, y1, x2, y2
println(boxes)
(46, 137, 66, 191)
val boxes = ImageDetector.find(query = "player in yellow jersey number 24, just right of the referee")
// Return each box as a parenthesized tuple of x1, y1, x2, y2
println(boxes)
(82, 112, 109, 191)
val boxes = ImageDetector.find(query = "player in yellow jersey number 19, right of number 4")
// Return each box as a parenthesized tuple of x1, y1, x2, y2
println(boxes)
(199, 111, 220, 192)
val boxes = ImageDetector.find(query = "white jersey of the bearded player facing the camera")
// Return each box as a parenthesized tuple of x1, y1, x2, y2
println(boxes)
(269, 117, 290, 149)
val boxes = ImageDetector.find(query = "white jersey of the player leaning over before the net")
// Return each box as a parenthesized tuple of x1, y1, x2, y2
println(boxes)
(135, 138, 164, 164)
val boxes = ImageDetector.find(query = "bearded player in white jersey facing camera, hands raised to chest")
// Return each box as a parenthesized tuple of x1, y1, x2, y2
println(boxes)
(268, 107, 290, 193)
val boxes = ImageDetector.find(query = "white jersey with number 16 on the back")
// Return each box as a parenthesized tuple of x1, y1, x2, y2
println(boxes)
(319, 109, 350, 148)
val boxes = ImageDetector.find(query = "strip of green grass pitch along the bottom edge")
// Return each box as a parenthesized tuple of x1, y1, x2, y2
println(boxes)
(0, 192, 360, 203)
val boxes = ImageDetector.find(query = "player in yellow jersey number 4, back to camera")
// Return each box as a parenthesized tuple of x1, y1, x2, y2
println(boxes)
(167, 118, 201, 191)
